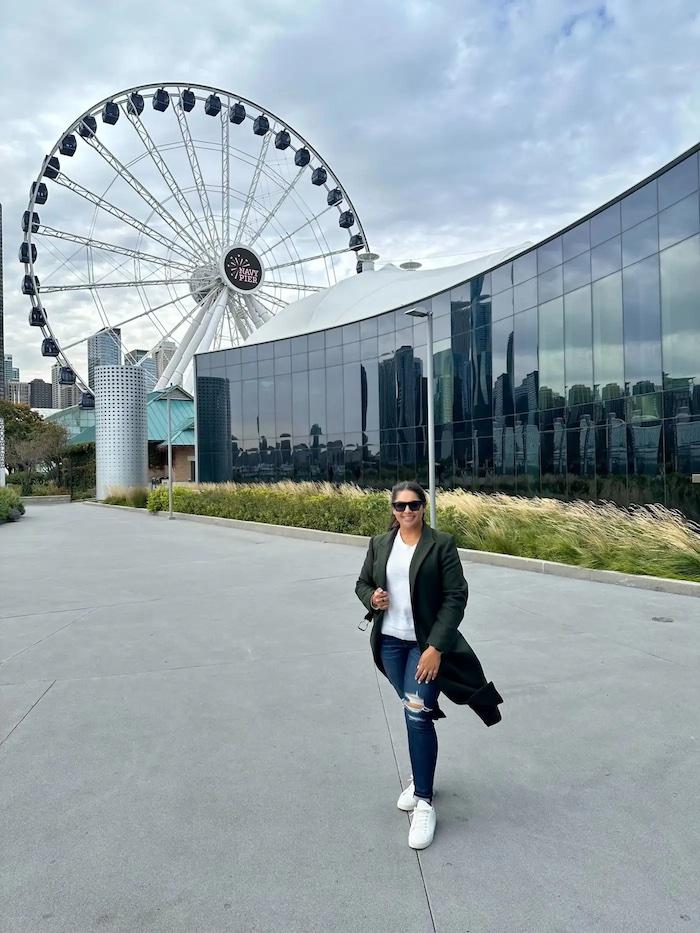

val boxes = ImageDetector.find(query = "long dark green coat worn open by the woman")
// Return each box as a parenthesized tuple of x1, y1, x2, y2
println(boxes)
(355, 525, 503, 726)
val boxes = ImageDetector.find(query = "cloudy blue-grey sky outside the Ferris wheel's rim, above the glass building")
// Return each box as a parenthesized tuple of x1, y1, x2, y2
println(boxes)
(0, 0, 700, 379)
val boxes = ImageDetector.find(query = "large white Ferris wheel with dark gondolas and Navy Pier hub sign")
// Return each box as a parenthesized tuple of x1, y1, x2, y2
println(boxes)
(19, 84, 368, 407)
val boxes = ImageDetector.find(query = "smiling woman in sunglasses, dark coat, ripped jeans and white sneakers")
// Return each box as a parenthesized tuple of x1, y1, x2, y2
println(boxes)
(355, 482, 503, 849)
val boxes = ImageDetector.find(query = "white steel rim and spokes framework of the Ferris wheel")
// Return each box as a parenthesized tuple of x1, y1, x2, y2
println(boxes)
(23, 81, 369, 395)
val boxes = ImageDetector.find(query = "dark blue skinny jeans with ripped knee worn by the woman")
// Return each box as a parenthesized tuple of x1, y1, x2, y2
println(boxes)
(380, 635, 440, 801)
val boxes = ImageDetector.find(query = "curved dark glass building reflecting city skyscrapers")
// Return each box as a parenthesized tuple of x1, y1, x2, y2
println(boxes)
(196, 146, 700, 519)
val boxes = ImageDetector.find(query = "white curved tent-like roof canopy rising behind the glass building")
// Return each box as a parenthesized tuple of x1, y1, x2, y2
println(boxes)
(246, 243, 531, 344)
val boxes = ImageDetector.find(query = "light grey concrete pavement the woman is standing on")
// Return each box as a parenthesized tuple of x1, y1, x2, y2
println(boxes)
(0, 505, 700, 933)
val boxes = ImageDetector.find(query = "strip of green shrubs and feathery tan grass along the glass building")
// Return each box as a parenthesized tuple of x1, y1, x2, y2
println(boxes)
(148, 482, 700, 582)
